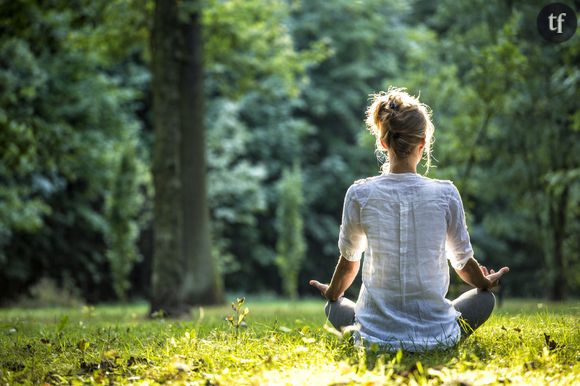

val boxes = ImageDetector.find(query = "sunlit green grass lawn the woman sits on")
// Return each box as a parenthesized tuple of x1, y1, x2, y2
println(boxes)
(0, 298, 580, 385)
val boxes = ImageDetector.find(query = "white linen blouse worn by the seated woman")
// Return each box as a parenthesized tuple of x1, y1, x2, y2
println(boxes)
(338, 173, 473, 352)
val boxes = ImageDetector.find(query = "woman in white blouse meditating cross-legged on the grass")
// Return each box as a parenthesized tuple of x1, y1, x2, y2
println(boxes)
(310, 88, 509, 351)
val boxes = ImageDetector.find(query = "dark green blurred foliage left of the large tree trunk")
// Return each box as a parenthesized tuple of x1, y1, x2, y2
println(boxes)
(0, 1, 147, 298)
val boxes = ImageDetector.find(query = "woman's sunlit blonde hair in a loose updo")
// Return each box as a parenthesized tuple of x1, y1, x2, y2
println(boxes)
(366, 87, 435, 174)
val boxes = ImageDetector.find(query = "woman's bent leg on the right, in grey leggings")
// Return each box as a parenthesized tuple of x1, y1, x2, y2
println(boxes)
(452, 288, 495, 337)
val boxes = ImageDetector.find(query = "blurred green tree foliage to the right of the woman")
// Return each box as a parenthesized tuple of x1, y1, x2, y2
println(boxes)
(392, 1, 580, 298)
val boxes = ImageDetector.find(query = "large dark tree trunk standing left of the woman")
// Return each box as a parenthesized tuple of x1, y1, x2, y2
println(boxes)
(151, 0, 222, 316)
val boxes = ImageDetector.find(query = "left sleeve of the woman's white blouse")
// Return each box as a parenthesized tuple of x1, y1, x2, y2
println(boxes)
(338, 185, 367, 261)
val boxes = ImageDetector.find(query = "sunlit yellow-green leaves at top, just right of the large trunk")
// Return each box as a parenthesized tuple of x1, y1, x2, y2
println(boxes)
(203, 0, 317, 99)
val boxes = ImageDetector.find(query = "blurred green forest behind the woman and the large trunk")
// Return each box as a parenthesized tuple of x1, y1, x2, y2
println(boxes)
(0, 0, 580, 305)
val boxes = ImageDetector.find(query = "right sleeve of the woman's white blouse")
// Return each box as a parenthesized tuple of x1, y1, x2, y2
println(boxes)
(447, 186, 473, 269)
